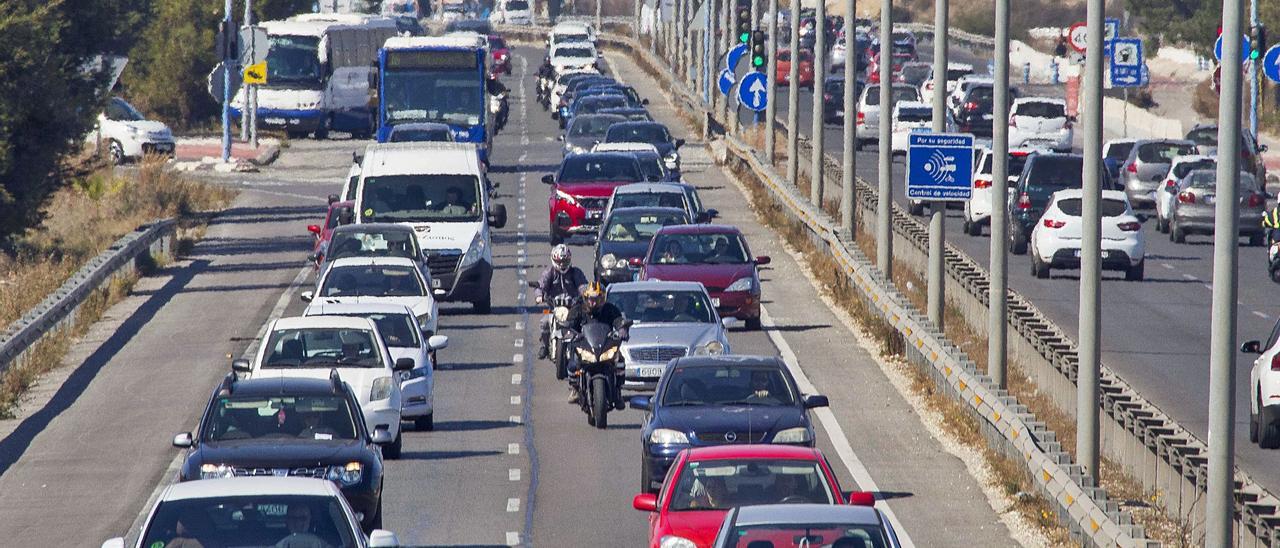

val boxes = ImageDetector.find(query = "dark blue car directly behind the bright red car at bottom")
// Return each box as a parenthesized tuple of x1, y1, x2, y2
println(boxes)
(631, 356, 827, 492)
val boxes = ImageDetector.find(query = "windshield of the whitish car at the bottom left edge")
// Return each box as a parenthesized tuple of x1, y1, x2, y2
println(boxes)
(138, 494, 358, 548)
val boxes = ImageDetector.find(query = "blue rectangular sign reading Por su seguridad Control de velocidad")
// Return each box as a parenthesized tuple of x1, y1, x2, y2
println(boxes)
(906, 133, 973, 201)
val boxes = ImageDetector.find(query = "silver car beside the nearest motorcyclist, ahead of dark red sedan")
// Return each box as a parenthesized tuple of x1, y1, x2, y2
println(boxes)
(607, 282, 737, 391)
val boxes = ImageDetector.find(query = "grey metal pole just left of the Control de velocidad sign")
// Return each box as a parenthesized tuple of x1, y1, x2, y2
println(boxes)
(876, 0, 893, 274)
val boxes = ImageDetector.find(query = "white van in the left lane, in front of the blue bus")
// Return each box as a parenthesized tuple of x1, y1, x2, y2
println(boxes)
(355, 142, 507, 314)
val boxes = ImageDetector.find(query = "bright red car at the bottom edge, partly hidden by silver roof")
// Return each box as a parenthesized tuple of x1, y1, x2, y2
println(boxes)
(631, 444, 874, 548)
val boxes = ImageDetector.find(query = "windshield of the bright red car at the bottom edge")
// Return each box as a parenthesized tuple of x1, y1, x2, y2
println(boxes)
(668, 458, 836, 512)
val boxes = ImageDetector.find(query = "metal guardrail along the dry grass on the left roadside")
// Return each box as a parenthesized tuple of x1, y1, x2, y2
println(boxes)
(0, 219, 178, 373)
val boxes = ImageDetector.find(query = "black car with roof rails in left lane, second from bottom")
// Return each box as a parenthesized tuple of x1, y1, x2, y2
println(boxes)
(173, 371, 392, 531)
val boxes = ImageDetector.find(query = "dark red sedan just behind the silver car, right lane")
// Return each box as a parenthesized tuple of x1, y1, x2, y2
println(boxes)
(640, 224, 769, 329)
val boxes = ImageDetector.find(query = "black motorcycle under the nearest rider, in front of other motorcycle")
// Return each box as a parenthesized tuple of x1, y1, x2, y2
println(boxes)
(568, 321, 623, 429)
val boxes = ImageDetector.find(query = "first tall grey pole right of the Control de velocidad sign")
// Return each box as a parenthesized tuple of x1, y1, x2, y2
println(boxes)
(988, 0, 1010, 388)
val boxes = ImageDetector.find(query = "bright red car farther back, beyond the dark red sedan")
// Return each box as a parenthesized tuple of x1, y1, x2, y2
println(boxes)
(543, 152, 645, 246)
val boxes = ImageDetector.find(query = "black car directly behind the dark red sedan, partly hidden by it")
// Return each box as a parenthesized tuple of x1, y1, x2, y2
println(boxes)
(595, 207, 689, 283)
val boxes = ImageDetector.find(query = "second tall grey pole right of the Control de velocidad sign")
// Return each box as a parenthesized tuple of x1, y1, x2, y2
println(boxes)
(1075, 0, 1105, 481)
